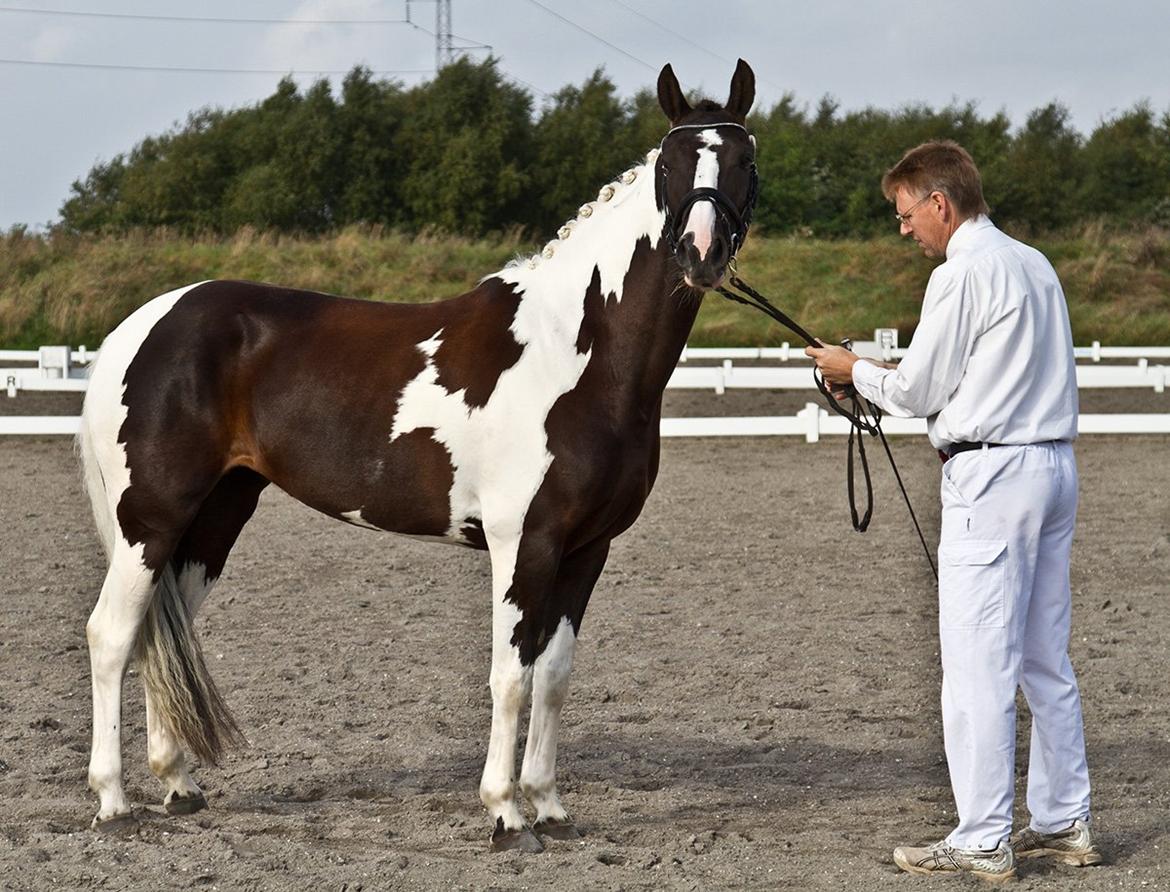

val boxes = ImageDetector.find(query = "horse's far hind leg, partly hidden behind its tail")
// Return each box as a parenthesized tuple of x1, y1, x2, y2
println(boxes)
(143, 468, 268, 815)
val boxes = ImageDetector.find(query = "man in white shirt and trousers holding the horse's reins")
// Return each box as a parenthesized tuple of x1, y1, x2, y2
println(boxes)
(806, 142, 1101, 881)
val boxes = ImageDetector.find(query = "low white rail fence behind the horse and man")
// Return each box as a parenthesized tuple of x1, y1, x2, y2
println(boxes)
(0, 339, 1170, 442)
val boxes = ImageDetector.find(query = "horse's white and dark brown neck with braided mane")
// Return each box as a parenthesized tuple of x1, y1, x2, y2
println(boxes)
(496, 151, 698, 402)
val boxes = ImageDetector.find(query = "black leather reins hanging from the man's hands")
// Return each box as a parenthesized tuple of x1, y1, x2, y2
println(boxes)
(716, 275, 938, 579)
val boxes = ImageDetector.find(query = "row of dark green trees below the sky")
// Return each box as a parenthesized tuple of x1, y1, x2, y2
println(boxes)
(56, 59, 1170, 236)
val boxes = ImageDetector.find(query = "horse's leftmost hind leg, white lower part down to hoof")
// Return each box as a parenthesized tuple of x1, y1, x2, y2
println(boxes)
(85, 536, 176, 829)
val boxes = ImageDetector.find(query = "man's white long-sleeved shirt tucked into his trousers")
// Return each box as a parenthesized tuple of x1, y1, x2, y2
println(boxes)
(853, 215, 1078, 450)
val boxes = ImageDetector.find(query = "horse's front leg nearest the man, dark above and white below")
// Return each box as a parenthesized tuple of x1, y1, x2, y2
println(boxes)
(519, 540, 610, 839)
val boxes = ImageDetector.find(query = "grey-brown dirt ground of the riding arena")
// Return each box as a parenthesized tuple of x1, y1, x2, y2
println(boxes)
(0, 392, 1170, 892)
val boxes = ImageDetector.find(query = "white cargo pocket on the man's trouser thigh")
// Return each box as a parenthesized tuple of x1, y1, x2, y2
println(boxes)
(938, 538, 1007, 629)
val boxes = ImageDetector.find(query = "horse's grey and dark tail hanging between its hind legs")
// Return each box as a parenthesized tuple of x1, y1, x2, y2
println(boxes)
(137, 563, 245, 764)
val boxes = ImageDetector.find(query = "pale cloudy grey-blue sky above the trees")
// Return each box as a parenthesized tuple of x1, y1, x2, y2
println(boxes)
(0, 0, 1170, 231)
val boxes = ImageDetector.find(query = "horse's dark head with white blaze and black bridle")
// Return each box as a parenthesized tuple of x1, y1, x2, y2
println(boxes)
(655, 59, 757, 289)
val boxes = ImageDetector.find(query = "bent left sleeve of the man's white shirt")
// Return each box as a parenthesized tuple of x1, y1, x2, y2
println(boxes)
(853, 267, 975, 418)
